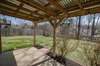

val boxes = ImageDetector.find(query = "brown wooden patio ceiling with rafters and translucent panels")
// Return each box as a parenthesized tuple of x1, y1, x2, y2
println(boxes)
(0, 0, 100, 22)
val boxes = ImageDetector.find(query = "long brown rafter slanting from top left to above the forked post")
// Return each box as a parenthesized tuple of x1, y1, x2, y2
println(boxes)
(18, 0, 55, 16)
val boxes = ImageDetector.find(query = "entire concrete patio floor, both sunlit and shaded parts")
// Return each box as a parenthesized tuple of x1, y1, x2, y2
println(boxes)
(0, 47, 81, 66)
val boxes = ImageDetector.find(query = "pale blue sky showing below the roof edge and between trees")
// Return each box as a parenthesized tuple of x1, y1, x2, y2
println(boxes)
(0, 13, 100, 25)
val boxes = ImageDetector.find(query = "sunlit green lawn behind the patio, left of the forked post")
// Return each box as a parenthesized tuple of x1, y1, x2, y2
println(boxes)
(2, 36, 52, 51)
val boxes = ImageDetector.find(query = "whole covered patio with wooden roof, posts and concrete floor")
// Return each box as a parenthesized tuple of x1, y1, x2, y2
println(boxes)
(0, 0, 100, 66)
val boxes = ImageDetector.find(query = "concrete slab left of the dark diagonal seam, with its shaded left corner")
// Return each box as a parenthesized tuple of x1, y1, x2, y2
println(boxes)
(0, 47, 49, 66)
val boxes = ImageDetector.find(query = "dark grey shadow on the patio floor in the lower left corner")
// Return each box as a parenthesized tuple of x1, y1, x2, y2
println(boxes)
(0, 52, 17, 66)
